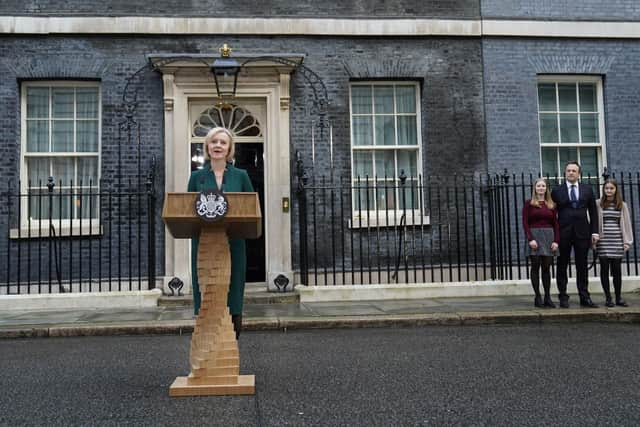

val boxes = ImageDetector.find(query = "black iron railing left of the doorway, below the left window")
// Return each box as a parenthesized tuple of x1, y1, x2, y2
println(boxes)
(0, 175, 157, 294)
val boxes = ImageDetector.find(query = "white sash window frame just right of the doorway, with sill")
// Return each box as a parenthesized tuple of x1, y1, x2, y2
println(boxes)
(349, 80, 429, 228)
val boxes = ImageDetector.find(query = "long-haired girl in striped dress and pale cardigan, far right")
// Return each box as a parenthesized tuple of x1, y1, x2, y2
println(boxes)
(596, 179, 633, 307)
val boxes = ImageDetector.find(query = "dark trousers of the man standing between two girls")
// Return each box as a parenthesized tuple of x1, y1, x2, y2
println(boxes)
(556, 234, 591, 301)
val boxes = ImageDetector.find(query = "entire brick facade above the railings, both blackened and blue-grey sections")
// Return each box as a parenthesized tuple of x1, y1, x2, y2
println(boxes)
(0, 0, 640, 288)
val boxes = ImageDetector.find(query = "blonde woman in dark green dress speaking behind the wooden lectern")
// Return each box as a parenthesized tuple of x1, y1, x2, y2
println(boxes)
(187, 127, 254, 338)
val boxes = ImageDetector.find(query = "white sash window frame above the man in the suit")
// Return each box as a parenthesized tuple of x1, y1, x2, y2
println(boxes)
(536, 75, 607, 179)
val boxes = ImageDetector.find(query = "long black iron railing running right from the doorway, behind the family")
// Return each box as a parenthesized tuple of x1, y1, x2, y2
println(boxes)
(294, 167, 640, 286)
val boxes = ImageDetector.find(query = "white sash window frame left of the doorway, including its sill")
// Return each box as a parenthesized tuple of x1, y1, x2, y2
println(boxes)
(16, 80, 102, 239)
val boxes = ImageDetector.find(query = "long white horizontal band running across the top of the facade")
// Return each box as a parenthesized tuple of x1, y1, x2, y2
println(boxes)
(0, 16, 640, 39)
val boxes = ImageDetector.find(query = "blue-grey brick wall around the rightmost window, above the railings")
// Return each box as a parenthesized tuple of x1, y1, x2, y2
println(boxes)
(483, 38, 640, 173)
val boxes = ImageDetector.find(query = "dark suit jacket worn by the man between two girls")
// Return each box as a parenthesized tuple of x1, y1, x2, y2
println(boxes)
(551, 183, 598, 240)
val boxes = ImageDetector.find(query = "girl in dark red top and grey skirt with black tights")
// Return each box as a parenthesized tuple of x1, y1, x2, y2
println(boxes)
(522, 178, 560, 307)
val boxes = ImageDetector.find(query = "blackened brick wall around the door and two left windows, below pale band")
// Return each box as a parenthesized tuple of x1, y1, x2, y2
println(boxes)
(0, 36, 486, 282)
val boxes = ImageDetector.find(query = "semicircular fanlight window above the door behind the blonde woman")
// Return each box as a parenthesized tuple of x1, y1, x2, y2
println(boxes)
(191, 104, 262, 137)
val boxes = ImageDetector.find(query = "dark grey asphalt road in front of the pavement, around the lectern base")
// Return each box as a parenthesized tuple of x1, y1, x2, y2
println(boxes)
(0, 323, 640, 427)
